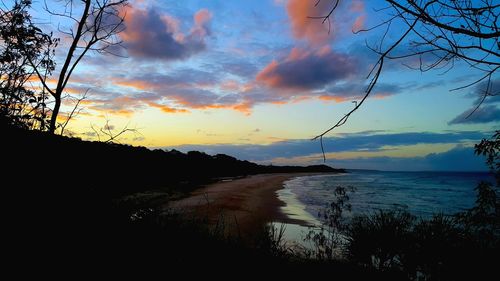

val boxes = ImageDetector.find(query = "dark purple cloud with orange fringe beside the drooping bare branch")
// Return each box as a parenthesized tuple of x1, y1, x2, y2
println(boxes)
(256, 47, 406, 102)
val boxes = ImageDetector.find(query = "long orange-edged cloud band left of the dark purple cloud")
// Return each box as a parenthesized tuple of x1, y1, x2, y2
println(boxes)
(110, 62, 362, 114)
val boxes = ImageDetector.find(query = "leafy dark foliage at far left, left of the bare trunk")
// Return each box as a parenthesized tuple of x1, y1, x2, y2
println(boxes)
(0, 0, 58, 130)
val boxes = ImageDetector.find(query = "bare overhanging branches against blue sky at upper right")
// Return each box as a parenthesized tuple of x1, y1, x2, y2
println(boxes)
(310, 0, 500, 153)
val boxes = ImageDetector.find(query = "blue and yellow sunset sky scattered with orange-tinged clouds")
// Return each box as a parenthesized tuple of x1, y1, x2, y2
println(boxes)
(24, 0, 500, 171)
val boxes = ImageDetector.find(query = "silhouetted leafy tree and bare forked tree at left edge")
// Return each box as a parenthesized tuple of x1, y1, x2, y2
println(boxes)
(0, 0, 127, 134)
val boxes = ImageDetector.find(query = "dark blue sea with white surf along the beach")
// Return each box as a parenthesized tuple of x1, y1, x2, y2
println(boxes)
(277, 170, 495, 243)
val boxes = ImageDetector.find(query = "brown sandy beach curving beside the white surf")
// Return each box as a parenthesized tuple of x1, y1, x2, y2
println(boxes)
(168, 173, 312, 234)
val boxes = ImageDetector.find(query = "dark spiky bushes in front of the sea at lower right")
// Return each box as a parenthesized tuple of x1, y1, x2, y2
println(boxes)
(306, 182, 500, 280)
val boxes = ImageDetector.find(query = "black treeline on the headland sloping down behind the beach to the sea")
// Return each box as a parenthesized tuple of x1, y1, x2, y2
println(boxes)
(2, 122, 344, 195)
